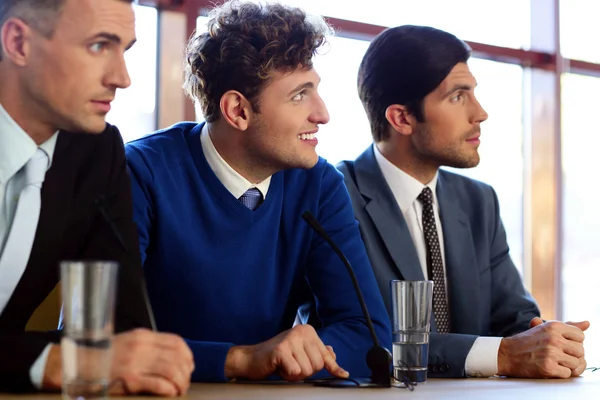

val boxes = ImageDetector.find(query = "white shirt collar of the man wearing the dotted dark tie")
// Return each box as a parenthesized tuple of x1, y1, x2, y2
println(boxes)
(373, 144, 439, 213)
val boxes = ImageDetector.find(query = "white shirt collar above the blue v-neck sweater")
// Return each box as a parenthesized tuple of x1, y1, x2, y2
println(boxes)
(200, 123, 271, 199)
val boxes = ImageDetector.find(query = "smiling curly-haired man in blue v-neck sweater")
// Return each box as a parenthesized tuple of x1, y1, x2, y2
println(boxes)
(126, 2, 391, 381)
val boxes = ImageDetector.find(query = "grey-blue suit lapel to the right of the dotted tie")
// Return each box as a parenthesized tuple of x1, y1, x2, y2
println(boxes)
(436, 171, 480, 334)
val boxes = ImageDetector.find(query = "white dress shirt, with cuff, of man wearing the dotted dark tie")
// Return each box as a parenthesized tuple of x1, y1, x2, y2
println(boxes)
(373, 145, 502, 377)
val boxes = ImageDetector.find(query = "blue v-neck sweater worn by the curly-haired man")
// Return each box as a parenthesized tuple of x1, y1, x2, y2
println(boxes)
(126, 123, 391, 381)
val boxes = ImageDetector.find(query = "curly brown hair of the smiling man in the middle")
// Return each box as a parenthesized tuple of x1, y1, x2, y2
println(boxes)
(183, 1, 333, 122)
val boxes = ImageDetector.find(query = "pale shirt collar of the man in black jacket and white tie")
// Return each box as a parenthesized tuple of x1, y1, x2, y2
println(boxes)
(0, 104, 58, 183)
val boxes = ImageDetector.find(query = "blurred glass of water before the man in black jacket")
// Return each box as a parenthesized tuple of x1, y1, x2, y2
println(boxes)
(60, 261, 118, 400)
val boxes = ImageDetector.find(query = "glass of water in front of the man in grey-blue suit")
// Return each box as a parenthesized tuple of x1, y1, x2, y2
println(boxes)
(390, 281, 433, 382)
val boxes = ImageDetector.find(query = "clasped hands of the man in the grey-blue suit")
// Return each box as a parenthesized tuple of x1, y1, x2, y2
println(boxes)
(498, 318, 590, 378)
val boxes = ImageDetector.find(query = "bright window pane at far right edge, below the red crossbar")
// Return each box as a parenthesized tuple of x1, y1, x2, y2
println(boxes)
(562, 74, 600, 366)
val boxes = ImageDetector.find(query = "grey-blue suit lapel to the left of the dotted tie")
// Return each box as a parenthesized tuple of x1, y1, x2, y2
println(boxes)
(354, 146, 425, 281)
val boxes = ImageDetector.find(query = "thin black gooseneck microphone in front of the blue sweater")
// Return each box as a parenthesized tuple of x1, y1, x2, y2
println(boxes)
(302, 211, 392, 387)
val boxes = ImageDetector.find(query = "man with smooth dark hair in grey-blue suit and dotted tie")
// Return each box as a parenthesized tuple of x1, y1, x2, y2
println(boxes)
(338, 26, 589, 378)
